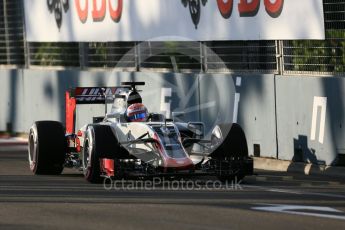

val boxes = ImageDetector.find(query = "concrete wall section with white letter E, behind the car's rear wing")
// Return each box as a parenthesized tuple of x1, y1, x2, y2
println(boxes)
(0, 70, 199, 132)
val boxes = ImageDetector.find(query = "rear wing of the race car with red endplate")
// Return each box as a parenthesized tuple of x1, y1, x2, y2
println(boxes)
(65, 86, 122, 134)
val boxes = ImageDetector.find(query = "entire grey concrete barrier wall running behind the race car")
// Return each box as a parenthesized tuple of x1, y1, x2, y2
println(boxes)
(0, 70, 345, 165)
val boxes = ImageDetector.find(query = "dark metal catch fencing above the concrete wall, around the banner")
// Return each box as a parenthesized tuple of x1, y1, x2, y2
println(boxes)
(0, 0, 345, 76)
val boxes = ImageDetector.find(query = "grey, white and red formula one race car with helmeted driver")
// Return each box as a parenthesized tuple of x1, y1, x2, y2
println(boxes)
(29, 82, 253, 183)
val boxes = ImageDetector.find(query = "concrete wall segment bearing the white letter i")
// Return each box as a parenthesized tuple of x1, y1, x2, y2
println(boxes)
(200, 74, 277, 157)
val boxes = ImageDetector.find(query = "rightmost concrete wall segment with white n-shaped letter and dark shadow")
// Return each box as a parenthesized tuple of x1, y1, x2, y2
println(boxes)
(276, 76, 345, 165)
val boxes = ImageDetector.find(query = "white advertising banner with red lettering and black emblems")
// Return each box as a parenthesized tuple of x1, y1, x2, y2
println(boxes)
(23, 0, 325, 42)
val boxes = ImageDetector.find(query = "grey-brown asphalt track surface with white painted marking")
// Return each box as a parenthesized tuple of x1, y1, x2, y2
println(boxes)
(0, 146, 345, 230)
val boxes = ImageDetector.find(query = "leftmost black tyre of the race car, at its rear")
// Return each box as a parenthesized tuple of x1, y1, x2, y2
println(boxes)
(28, 121, 67, 175)
